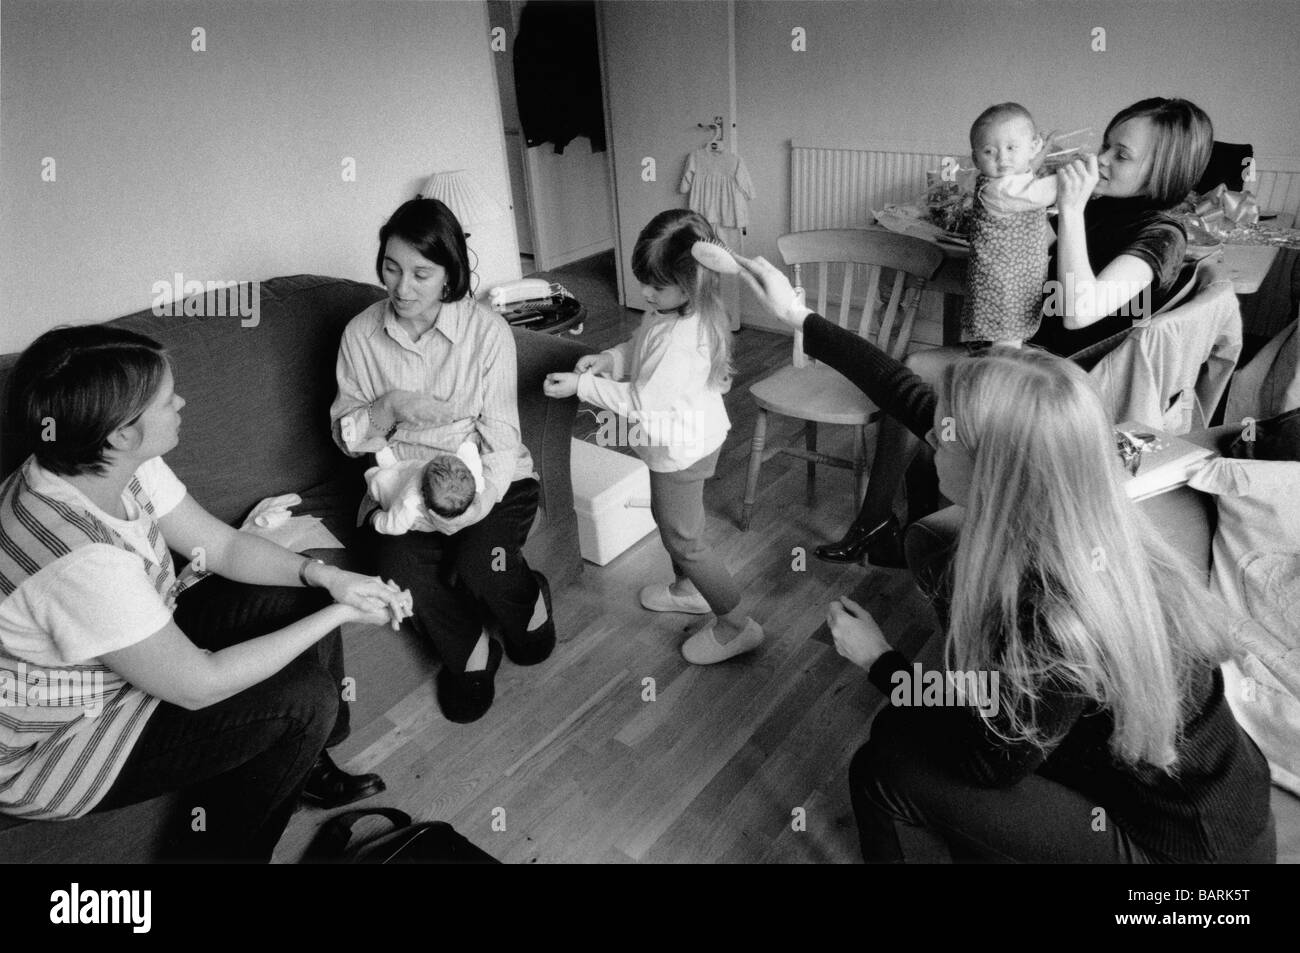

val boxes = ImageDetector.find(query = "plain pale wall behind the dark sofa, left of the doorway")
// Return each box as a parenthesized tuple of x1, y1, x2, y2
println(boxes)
(0, 0, 520, 351)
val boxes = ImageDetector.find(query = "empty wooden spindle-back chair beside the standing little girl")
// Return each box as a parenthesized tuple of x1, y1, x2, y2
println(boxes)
(740, 229, 944, 530)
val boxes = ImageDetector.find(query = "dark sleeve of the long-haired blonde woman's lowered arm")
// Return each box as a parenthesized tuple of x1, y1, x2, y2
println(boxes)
(867, 650, 1087, 788)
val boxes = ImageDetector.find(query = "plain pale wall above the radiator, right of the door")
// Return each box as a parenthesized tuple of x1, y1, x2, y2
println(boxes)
(733, 0, 1300, 330)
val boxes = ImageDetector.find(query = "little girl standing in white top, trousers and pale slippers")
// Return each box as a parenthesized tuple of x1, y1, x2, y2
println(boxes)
(543, 209, 763, 664)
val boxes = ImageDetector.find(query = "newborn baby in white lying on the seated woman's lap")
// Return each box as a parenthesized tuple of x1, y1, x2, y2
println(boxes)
(365, 441, 484, 536)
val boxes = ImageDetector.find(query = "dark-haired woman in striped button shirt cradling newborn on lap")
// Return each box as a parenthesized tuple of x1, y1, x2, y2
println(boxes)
(330, 199, 555, 722)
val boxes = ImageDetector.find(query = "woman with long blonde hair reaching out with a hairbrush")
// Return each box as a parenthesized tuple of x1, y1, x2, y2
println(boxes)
(742, 259, 1277, 862)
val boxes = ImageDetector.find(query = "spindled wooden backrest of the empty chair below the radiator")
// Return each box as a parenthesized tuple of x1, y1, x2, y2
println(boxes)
(776, 229, 944, 364)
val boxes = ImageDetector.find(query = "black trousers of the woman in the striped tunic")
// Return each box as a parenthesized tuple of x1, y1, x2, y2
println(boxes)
(95, 576, 348, 862)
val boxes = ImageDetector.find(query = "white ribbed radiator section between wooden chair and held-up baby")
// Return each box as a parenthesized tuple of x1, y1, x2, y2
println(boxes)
(790, 142, 954, 231)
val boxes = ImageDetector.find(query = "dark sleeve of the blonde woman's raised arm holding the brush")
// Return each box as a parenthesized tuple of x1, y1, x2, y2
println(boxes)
(803, 313, 939, 439)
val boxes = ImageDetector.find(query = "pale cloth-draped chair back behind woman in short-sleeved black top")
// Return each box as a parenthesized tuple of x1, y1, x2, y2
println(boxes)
(1088, 268, 1242, 436)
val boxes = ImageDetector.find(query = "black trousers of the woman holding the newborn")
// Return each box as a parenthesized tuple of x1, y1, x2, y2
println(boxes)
(361, 478, 540, 672)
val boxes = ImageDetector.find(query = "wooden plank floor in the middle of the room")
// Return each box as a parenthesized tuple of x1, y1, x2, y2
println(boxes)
(276, 257, 1300, 863)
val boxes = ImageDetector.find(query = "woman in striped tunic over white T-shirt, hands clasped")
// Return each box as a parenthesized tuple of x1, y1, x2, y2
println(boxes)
(0, 325, 406, 861)
